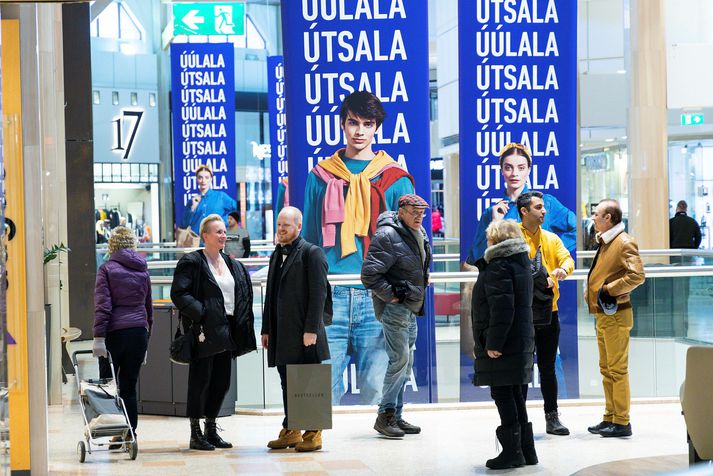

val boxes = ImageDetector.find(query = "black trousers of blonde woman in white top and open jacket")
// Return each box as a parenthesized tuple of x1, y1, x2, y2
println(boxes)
(186, 351, 232, 418)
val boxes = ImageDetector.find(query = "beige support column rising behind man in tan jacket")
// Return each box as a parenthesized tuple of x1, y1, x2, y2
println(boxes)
(629, 0, 669, 249)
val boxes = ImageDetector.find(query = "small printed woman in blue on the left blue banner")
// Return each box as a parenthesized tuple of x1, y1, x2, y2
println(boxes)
(182, 165, 237, 234)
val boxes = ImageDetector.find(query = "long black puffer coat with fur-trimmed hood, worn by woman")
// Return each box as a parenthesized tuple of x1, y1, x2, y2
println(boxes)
(471, 238, 535, 386)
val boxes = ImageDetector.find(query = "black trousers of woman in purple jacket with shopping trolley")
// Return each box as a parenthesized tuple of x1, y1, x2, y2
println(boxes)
(99, 327, 149, 431)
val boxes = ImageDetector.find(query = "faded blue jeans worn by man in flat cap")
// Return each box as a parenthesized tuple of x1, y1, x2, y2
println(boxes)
(379, 303, 418, 419)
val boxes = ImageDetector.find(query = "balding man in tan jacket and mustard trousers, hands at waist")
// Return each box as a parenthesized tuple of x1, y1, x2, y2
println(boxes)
(586, 199, 645, 437)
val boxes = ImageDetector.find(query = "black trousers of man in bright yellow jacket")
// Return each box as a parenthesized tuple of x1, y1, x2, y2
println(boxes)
(522, 311, 560, 413)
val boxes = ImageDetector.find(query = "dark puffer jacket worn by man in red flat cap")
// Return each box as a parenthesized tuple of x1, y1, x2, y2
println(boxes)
(361, 212, 431, 319)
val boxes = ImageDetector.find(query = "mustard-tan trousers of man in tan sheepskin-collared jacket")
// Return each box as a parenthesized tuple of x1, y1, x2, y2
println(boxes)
(596, 308, 634, 425)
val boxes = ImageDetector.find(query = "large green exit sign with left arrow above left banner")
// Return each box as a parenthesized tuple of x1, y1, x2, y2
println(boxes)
(173, 3, 245, 35)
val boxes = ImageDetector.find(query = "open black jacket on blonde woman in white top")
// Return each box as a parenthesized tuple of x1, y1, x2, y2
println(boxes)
(171, 250, 257, 358)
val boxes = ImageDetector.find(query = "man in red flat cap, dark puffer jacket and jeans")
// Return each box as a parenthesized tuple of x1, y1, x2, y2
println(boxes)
(361, 194, 431, 438)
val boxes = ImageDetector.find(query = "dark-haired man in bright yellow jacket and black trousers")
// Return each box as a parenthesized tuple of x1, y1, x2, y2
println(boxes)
(517, 191, 574, 435)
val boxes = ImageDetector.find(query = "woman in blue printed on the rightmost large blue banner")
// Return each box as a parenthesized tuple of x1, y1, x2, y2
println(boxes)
(466, 143, 577, 265)
